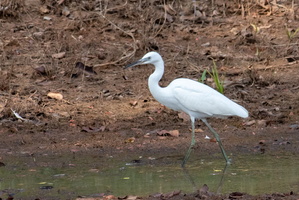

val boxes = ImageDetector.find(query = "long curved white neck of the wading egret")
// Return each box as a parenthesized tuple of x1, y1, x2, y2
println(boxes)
(148, 60, 164, 97)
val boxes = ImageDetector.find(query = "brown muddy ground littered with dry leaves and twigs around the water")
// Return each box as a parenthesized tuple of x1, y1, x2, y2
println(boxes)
(0, 0, 299, 199)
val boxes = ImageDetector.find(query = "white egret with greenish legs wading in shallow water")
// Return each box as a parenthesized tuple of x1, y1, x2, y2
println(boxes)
(125, 52, 248, 167)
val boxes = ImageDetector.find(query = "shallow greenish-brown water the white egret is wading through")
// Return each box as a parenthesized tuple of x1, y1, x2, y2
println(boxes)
(0, 155, 299, 198)
